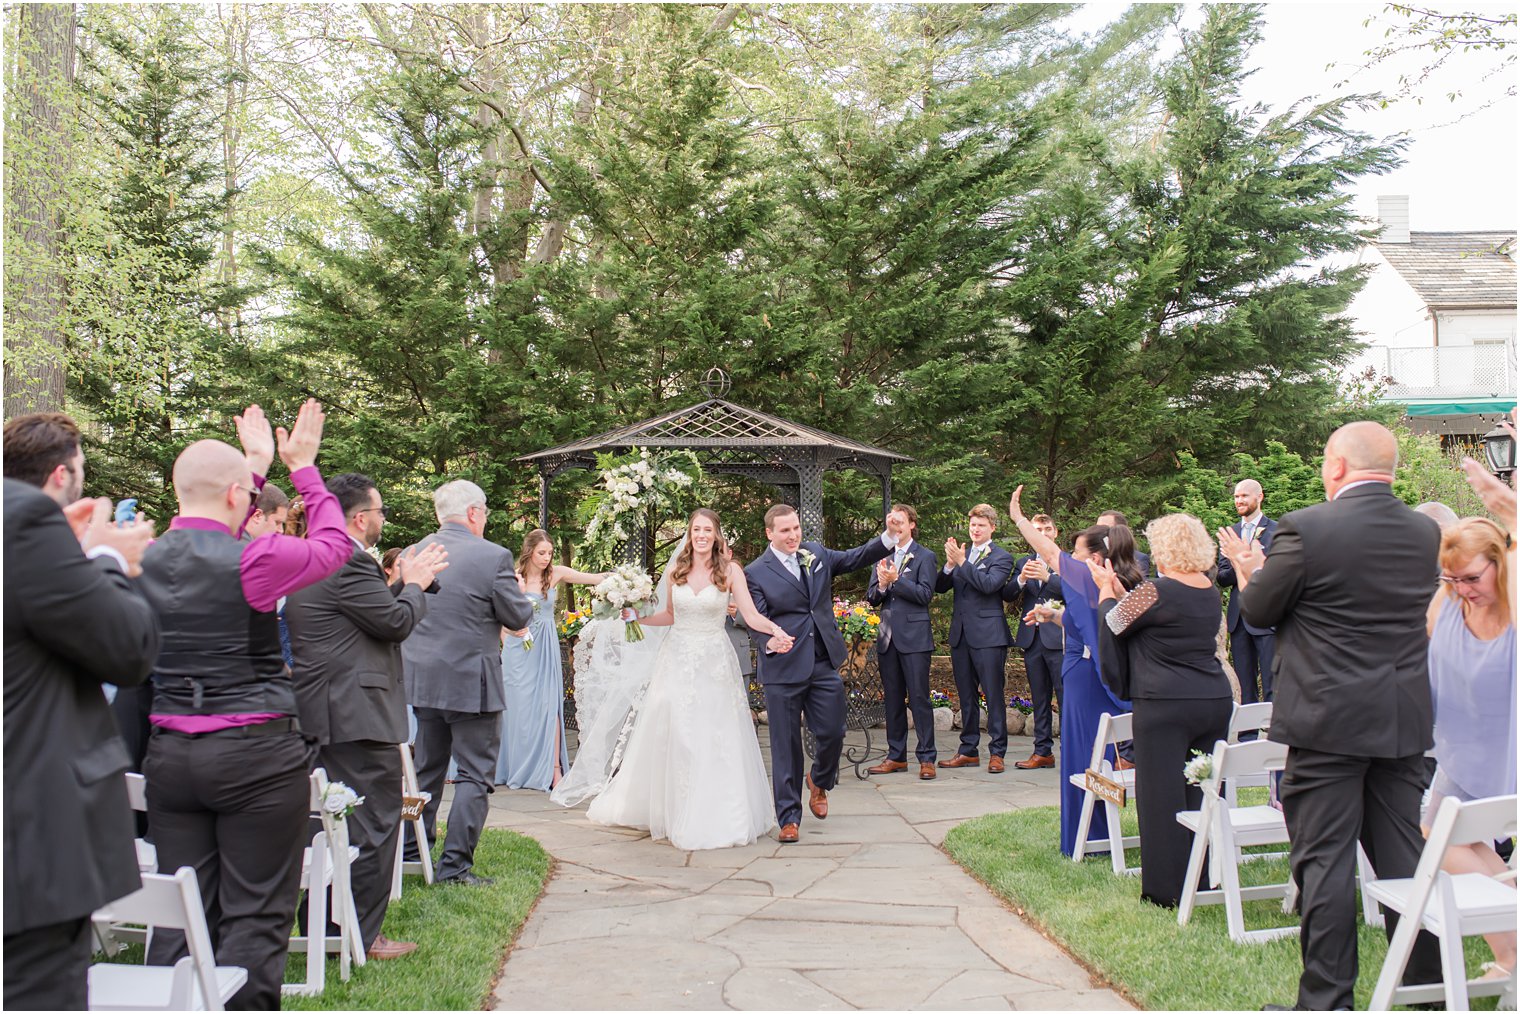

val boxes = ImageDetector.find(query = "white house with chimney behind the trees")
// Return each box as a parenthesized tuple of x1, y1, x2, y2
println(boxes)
(1350, 196, 1515, 438)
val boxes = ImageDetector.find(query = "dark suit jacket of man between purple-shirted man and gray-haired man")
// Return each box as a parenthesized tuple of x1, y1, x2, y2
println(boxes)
(286, 547, 427, 745)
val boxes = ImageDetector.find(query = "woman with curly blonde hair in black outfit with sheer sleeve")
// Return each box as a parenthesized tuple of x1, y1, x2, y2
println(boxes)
(1094, 514, 1233, 908)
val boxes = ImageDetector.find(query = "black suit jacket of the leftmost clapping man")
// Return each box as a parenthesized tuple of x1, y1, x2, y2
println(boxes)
(5, 479, 158, 936)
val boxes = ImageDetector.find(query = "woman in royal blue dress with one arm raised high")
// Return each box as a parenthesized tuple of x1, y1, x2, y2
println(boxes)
(1008, 486, 1145, 856)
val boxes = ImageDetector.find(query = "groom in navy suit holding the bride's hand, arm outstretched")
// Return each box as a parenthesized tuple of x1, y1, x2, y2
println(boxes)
(745, 503, 897, 845)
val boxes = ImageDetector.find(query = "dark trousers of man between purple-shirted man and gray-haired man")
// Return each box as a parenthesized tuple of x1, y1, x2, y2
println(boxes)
(316, 740, 401, 947)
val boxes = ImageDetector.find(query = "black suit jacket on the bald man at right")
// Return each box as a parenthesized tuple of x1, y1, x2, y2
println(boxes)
(1240, 482, 1441, 757)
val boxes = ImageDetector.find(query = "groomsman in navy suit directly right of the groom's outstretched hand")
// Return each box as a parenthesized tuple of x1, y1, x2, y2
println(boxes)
(865, 503, 939, 781)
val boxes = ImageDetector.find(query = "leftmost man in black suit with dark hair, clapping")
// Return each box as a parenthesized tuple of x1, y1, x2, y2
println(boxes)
(5, 412, 160, 1011)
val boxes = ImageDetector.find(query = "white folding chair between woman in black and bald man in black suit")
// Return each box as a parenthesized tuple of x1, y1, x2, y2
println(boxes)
(1176, 739, 1298, 944)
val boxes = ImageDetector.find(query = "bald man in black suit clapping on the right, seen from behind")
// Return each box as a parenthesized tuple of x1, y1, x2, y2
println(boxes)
(1219, 423, 1441, 1011)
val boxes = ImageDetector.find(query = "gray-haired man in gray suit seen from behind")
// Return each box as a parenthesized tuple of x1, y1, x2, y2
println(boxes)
(401, 479, 534, 883)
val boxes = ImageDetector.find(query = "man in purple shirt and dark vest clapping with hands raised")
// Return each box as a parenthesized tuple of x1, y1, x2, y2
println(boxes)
(140, 400, 353, 1009)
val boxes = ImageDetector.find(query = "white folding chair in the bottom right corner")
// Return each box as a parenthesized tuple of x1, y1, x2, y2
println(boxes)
(1362, 795, 1517, 1011)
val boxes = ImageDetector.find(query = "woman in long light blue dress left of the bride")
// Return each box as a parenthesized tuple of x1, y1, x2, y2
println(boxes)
(496, 528, 606, 792)
